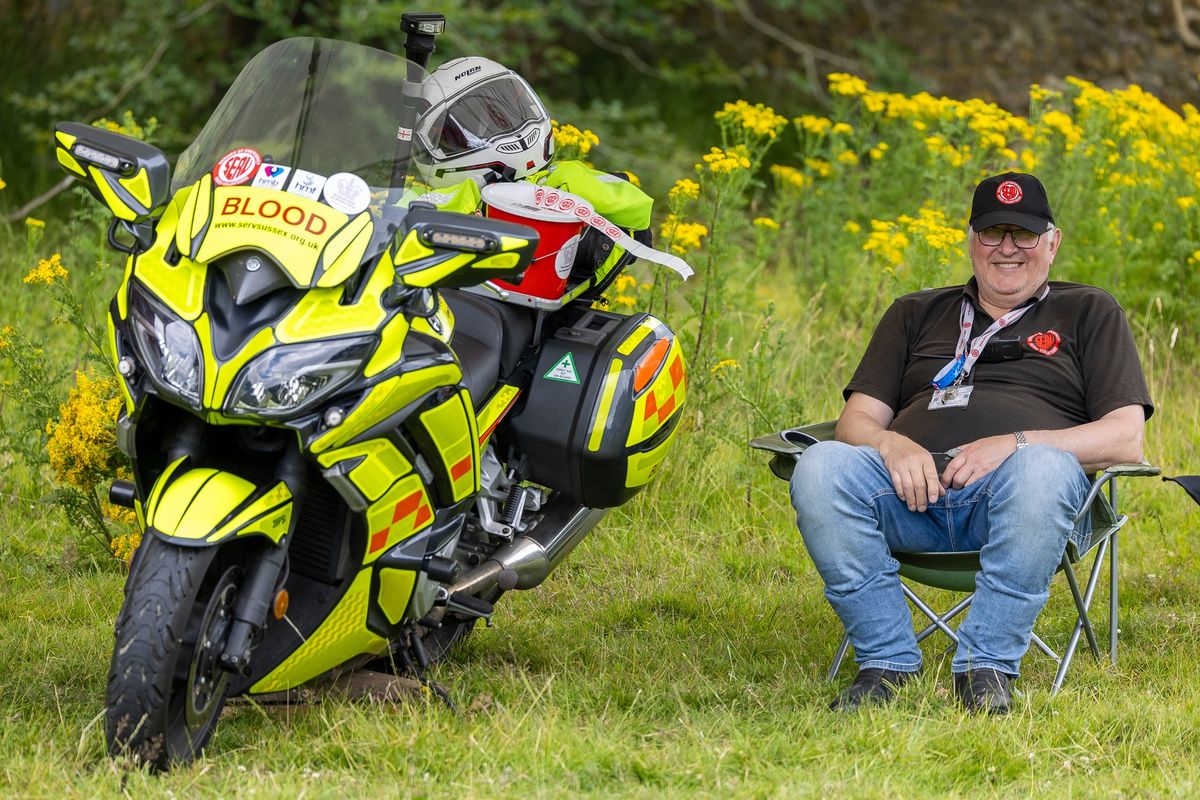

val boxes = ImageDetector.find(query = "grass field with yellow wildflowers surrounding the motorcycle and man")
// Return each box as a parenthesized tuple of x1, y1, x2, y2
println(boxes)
(0, 73, 1200, 798)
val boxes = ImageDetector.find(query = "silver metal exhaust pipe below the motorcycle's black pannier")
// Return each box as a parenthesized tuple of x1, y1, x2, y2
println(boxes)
(446, 506, 608, 595)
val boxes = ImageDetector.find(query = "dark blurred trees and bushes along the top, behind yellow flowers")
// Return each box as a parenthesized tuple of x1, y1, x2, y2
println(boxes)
(0, 0, 1200, 215)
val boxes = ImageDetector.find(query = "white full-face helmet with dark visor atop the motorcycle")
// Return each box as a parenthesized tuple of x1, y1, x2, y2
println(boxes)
(414, 56, 554, 187)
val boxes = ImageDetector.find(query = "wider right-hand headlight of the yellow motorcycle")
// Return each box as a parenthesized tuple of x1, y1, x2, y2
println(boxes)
(229, 336, 374, 416)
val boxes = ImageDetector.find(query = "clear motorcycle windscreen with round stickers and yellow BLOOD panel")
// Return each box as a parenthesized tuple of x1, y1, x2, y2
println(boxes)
(172, 37, 448, 285)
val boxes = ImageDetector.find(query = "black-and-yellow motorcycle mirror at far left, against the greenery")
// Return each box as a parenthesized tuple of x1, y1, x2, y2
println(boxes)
(54, 122, 170, 223)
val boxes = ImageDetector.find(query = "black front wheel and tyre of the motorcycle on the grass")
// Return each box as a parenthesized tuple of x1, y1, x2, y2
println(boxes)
(104, 537, 242, 770)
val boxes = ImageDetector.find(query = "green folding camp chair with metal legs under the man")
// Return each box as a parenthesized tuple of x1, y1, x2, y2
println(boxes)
(750, 421, 1160, 693)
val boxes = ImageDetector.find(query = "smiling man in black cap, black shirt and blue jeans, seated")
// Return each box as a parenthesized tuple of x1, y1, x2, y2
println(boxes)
(791, 173, 1153, 714)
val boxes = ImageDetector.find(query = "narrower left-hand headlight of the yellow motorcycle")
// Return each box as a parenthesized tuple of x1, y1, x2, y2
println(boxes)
(130, 283, 204, 408)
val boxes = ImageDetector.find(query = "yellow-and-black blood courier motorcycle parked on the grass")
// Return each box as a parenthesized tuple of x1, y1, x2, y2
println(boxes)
(55, 14, 686, 769)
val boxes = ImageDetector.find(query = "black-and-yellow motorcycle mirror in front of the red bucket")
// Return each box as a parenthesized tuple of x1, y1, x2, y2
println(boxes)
(392, 204, 538, 289)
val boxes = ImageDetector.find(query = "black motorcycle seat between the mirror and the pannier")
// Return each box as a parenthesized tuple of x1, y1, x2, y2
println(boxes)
(442, 289, 533, 409)
